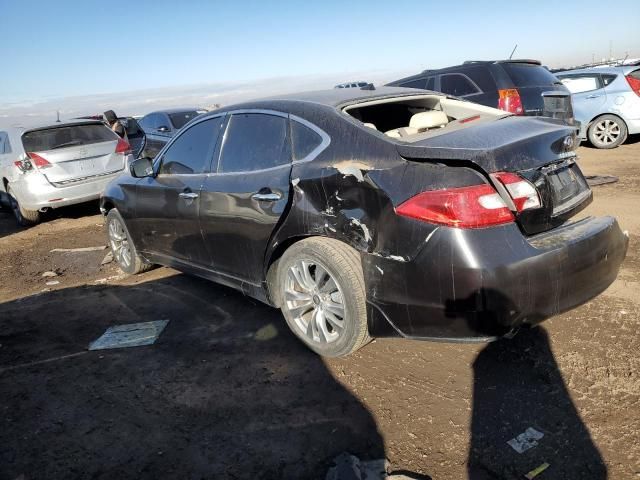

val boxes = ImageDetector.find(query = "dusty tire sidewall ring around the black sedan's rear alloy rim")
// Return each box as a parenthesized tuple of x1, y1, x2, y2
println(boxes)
(278, 242, 366, 357)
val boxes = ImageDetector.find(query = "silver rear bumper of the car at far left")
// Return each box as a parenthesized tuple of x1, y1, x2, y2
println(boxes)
(11, 170, 124, 210)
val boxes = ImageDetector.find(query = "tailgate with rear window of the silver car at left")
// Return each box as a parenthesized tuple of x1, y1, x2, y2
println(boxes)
(22, 122, 125, 187)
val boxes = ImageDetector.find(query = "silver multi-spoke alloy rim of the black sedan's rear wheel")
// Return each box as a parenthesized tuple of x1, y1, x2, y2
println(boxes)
(284, 260, 347, 344)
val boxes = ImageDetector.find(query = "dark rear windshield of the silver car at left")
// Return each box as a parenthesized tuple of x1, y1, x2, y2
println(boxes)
(22, 124, 117, 152)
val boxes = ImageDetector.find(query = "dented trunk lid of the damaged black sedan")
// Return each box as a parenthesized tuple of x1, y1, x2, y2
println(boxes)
(397, 116, 592, 235)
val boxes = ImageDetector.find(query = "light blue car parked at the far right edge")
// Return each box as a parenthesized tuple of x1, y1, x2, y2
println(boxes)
(555, 66, 640, 148)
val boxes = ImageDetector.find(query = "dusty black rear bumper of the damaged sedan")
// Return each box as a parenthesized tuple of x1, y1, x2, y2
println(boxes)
(363, 217, 628, 341)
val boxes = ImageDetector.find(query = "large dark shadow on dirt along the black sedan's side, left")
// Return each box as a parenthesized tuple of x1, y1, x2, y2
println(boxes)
(0, 275, 384, 479)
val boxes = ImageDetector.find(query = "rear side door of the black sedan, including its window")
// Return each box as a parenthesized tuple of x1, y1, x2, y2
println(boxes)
(200, 110, 291, 285)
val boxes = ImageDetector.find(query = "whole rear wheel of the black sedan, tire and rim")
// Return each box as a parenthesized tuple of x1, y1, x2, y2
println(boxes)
(276, 237, 371, 357)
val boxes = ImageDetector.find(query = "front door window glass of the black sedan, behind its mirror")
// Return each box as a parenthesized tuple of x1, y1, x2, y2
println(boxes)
(158, 117, 223, 175)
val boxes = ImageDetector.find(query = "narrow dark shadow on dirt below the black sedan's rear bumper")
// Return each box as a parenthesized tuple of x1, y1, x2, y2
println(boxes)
(468, 327, 607, 480)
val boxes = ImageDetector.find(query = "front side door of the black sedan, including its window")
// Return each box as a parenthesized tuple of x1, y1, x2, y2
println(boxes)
(133, 115, 224, 266)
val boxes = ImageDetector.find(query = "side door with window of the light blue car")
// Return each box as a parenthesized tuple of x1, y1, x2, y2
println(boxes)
(558, 73, 607, 126)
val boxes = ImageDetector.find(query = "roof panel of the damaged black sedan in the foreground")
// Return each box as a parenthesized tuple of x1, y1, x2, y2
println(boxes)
(226, 87, 443, 111)
